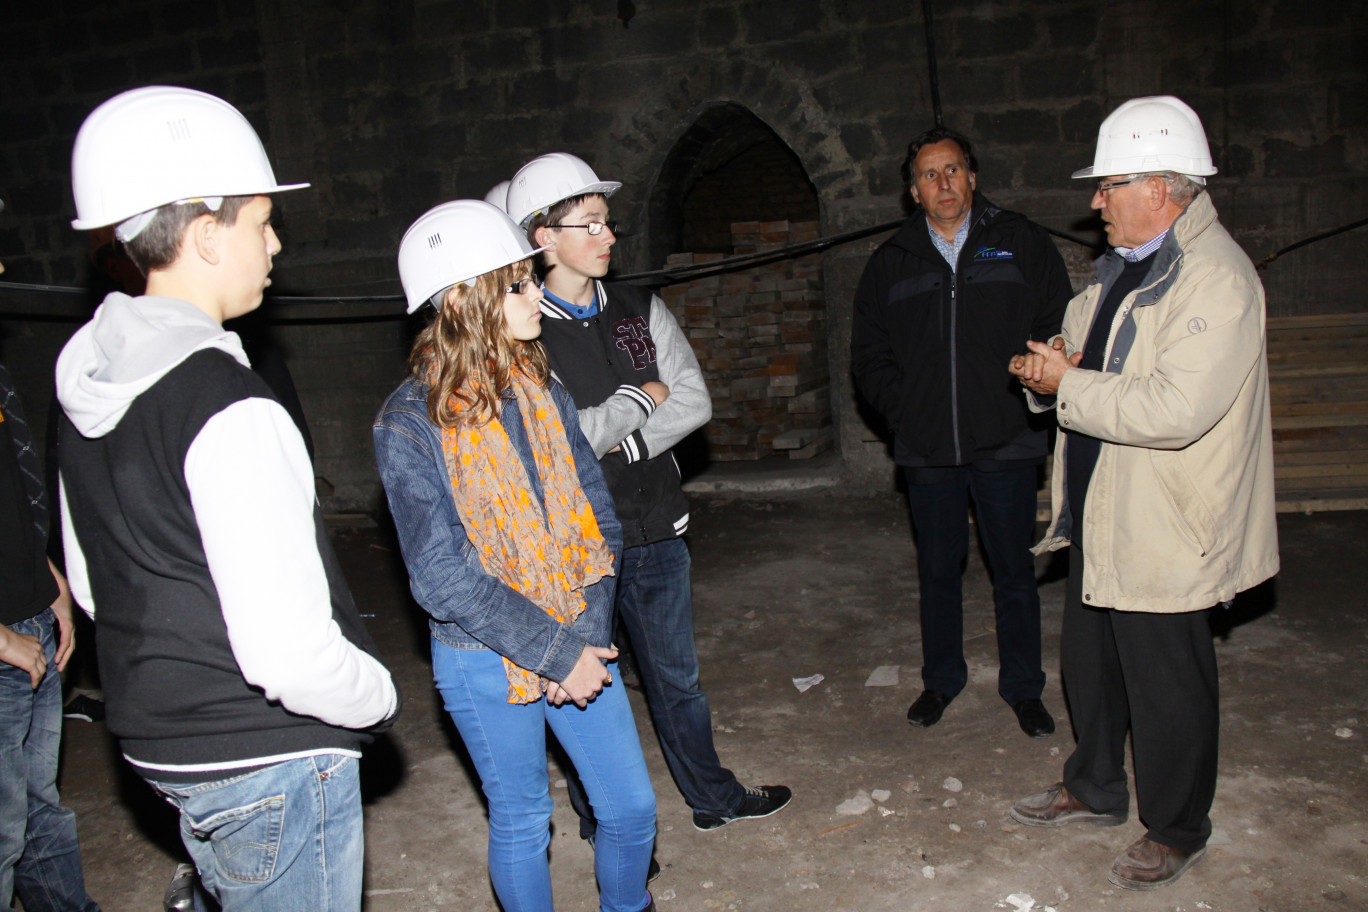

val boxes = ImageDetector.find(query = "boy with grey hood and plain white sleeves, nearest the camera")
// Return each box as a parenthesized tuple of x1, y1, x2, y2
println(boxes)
(57, 86, 398, 912)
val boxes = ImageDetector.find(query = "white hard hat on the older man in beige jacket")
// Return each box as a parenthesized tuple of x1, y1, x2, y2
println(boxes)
(1074, 94, 1216, 183)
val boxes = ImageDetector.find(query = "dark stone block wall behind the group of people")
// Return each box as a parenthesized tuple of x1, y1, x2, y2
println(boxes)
(0, 0, 1368, 509)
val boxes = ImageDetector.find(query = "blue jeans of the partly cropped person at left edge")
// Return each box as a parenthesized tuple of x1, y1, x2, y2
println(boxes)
(0, 608, 100, 912)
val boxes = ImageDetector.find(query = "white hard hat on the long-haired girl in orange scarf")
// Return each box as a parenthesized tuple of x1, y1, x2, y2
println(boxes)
(399, 200, 546, 313)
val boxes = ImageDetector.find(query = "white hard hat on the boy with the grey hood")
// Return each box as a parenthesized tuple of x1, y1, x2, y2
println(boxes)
(71, 86, 309, 239)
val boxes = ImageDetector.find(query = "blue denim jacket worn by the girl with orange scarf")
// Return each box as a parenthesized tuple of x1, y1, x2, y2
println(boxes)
(372, 377, 622, 681)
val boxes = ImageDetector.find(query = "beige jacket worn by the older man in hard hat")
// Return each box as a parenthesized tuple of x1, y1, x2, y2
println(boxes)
(1027, 193, 1278, 613)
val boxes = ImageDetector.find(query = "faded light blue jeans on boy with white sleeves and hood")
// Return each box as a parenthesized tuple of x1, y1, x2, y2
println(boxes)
(148, 753, 365, 912)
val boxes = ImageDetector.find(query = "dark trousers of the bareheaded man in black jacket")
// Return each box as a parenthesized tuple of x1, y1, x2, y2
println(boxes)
(903, 462, 1045, 706)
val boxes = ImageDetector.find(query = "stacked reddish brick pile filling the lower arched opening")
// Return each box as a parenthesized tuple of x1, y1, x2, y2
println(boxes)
(662, 222, 832, 461)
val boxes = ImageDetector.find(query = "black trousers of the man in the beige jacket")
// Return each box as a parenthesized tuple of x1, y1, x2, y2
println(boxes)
(1060, 547, 1220, 852)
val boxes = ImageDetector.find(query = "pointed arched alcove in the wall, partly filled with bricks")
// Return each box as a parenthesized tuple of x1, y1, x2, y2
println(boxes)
(648, 103, 833, 461)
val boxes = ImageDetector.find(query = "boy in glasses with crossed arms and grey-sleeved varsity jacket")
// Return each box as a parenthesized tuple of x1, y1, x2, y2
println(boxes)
(508, 152, 792, 838)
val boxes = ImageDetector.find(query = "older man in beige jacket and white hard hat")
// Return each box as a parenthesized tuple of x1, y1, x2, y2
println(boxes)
(1008, 96, 1278, 890)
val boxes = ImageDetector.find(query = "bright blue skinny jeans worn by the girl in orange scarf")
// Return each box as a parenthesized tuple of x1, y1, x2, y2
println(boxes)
(432, 639, 655, 912)
